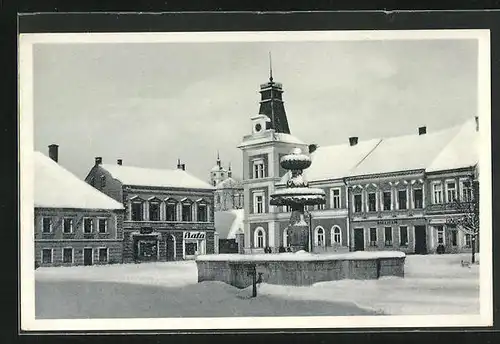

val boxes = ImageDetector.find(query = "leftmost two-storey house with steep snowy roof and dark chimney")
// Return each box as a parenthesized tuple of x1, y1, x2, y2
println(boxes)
(34, 145, 124, 266)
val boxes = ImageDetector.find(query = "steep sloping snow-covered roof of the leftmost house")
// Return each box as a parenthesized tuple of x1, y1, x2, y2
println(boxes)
(34, 152, 123, 210)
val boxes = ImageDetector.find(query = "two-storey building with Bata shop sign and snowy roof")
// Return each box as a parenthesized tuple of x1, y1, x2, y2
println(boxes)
(85, 157, 217, 262)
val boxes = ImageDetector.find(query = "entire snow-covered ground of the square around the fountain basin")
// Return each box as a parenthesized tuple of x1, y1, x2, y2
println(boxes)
(35, 254, 479, 319)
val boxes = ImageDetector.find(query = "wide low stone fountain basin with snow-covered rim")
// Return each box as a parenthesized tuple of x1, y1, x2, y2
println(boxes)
(196, 251, 406, 288)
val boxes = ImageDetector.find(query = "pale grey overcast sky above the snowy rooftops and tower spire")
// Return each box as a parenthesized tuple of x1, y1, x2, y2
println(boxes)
(33, 40, 478, 180)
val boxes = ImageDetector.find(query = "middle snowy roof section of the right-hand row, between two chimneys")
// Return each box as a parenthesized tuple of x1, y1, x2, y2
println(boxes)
(349, 126, 460, 176)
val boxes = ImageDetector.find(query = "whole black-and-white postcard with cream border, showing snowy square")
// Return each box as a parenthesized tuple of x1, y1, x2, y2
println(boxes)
(21, 28, 492, 330)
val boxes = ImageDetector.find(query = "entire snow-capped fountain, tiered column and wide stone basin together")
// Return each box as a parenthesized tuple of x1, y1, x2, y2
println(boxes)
(196, 148, 406, 288)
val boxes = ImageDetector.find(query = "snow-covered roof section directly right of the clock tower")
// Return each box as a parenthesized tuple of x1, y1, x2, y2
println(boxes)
(304, 139, 381, 182)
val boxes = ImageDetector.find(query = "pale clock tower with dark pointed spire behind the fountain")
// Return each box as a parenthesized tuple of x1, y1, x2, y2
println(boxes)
(238, 60, 307, 253)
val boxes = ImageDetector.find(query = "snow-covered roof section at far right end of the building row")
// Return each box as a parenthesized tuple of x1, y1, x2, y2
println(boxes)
(426, 120, 479, 172)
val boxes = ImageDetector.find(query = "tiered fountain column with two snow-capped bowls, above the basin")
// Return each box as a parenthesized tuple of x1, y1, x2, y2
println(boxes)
(269, 148, 325, 252)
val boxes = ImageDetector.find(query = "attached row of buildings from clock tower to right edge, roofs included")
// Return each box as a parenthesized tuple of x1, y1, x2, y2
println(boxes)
(239, 70, 479, 254)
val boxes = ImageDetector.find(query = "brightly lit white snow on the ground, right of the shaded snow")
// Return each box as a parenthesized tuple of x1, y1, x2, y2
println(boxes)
(260, 254, 479, 315)
